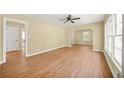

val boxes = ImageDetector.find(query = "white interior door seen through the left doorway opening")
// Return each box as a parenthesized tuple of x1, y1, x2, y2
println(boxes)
(6, 27, 19, 51)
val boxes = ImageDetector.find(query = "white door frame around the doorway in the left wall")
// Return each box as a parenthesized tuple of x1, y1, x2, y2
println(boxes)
(2, 17, 28, 63)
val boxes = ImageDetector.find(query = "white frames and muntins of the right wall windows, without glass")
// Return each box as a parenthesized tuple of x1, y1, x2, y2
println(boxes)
(104, 14, 122, 68)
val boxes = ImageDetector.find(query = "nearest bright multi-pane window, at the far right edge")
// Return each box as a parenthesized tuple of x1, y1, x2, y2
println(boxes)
(113, 15, 122, 65)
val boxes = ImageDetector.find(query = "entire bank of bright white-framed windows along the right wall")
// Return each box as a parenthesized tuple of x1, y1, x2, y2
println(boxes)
(104, 15, 122, 66)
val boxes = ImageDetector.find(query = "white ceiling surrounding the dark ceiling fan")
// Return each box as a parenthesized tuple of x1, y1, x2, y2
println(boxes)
(27, 14, 105, 26)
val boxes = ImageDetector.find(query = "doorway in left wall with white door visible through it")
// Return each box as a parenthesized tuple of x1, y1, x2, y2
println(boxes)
(3, 17, 27, 63)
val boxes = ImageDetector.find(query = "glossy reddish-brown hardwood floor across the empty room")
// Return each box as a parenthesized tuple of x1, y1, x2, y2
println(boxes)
(0, 45, 113, 78)
